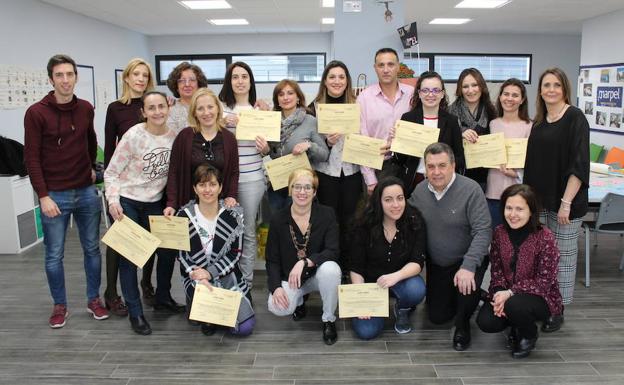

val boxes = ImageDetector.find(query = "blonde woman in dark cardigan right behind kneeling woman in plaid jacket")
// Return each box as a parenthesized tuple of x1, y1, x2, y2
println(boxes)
(165, 88, 238, 215)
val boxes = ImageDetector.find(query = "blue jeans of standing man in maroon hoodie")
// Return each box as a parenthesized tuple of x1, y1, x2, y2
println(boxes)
(41, 185, 102, 305)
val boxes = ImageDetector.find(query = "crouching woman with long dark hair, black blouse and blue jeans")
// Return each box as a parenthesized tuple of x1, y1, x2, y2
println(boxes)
(350, 177, 427, 340)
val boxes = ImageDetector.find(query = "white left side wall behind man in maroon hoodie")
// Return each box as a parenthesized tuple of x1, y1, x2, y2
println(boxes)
(0, 0, 149, 146)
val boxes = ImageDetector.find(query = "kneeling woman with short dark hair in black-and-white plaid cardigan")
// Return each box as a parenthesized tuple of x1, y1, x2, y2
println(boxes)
(178, 164, 256, 336)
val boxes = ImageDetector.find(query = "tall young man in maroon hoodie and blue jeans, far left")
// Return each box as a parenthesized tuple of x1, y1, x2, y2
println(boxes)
(24, 55, 108, 328)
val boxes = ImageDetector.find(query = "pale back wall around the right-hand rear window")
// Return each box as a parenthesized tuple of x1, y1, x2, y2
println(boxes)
(419, 33, 581, 116)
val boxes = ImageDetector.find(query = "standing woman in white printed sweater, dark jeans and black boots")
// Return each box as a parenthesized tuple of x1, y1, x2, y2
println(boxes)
(104, 91, 183, 335)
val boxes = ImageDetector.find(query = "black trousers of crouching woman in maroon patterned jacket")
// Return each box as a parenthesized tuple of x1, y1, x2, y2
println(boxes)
(477, 294, 550, 338)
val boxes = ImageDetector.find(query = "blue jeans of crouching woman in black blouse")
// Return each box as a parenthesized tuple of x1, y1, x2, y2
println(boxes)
(351, 275, 426, 340)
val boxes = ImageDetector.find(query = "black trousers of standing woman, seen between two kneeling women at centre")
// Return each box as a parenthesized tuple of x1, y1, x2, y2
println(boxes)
(316, 172, 362, 271)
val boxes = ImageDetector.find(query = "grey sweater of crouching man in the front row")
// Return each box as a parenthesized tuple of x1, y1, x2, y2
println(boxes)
(408, 174, 492, 272)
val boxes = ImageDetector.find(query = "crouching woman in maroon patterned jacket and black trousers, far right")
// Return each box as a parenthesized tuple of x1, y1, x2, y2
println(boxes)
(477, 184, 563, 358)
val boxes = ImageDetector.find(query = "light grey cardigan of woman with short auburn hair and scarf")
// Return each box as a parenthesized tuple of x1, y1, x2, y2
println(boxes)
(269, 114, 329, 163)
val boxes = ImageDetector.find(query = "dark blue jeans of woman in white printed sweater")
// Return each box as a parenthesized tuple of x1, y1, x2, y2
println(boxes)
(119, 197, 176, 317)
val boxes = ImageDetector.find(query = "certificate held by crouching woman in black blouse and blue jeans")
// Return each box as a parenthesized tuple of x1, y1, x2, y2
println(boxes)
(338, 283, 390, 318)
